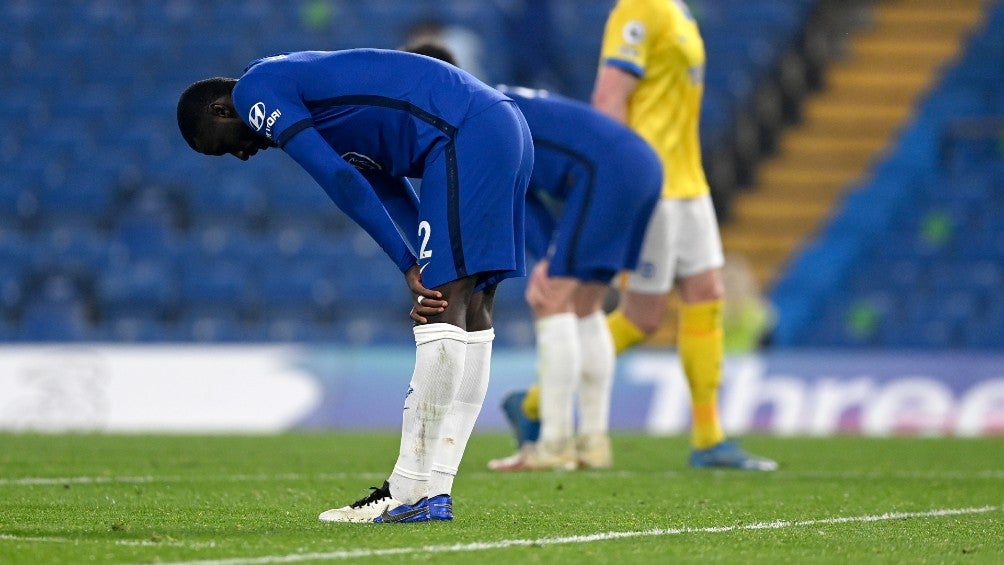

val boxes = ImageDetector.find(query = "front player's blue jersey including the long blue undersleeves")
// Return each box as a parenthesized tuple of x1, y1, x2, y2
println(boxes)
(233, 49, 511, 271)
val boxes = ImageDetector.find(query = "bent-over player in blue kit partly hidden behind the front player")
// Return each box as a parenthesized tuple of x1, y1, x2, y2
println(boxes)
(408, 44, 663, 471)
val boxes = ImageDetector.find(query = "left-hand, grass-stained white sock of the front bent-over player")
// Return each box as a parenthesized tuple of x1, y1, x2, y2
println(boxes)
(389, 323, 467, 504)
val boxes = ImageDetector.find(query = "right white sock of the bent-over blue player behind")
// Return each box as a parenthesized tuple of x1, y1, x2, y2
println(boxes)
(578, 311, 616, 436)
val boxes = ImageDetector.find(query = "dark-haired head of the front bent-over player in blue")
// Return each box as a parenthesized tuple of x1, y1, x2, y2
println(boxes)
(178, 78, 272, 161)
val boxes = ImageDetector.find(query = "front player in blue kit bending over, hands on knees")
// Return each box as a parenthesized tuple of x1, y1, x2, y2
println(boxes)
(178, 49, 533, 523)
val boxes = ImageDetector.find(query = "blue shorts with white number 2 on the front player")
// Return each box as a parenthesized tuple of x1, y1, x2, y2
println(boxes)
(415, 101, 533, 290)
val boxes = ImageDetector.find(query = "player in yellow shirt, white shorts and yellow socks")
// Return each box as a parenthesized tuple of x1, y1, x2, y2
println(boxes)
(493, 0, 777, 471)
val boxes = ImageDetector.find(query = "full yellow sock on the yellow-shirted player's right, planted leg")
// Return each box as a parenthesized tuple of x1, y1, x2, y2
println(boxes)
(678, 300, 725, 450)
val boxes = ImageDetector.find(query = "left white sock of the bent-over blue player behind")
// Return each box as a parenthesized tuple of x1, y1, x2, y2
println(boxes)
(534, 312, 582, 444)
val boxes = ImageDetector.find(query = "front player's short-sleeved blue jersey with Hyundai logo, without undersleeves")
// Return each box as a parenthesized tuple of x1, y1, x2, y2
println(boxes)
(234, 49, 506, 178)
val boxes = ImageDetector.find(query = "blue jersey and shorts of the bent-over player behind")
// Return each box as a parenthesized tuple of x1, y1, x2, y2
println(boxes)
(499, 86, 662, 282)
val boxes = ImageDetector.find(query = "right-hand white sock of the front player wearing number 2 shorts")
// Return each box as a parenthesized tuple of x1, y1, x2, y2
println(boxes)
(429, 328, 495, 497)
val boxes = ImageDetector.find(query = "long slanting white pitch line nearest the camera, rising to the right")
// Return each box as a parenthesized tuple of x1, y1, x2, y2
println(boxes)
(152, 506, 1004, 565)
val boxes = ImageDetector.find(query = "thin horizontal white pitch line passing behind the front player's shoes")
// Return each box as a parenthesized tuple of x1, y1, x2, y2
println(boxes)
(0, 470, 1004, 487)
